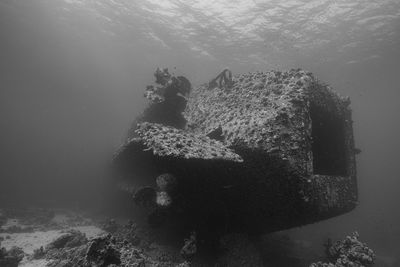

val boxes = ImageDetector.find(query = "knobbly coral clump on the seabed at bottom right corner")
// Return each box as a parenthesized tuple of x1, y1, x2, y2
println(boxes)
(310, 232, 375, 267)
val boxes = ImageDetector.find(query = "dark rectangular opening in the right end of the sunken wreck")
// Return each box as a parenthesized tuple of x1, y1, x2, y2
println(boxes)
(310, 105, 348, 176)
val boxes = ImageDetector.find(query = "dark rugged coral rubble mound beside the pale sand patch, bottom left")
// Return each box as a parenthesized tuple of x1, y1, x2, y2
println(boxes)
(45, 221, 184, 267)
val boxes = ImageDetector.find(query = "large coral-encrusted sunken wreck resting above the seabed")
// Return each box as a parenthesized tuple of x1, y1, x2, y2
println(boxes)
(114, 69, 357, 240)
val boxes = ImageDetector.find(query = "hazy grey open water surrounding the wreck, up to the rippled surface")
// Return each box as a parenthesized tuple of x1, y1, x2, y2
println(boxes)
(0, 0, 400, 266)
